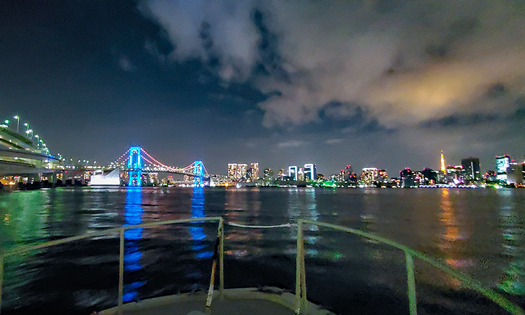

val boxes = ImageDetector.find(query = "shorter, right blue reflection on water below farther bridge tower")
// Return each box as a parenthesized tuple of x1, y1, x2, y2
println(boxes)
(190, 186, 213, 259)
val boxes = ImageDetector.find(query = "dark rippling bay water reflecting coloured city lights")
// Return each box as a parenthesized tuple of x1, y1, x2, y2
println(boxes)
(0, 188, 525, 314)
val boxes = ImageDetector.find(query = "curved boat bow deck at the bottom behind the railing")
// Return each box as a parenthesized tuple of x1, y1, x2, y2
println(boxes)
(98, 288, 333, 315)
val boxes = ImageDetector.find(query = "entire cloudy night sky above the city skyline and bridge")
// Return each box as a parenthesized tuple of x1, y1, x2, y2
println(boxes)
(0, 0, 525, 176)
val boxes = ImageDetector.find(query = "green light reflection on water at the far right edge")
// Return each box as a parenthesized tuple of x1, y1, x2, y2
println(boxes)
(498, 190, 525, 295)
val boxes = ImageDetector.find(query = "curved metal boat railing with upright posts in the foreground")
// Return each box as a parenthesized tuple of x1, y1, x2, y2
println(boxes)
(0, 217, 525, 315)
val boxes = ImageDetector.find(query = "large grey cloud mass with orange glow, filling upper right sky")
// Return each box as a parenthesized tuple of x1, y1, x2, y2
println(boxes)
(141, 0, 525, 127)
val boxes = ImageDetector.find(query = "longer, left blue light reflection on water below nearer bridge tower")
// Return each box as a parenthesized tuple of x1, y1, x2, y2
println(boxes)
(122, 187, 146, 302)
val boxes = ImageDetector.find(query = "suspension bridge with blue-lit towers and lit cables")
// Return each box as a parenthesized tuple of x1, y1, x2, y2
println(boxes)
(109, 146, 210, 186)
